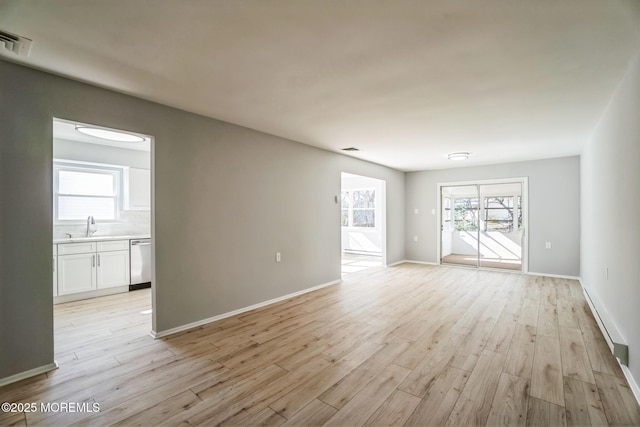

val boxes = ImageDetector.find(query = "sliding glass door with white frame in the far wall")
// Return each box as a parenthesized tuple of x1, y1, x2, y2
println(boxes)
(438, 178, 528, 272)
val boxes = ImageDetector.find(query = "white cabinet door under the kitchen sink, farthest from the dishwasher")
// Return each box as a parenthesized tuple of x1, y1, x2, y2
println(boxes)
(58, 253, 96, 295)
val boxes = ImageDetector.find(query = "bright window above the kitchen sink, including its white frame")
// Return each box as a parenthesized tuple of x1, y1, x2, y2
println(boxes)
(53, 162, 122, 222)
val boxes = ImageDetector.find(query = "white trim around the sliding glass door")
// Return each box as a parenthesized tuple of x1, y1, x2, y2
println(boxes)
(436, 176, 529, 274)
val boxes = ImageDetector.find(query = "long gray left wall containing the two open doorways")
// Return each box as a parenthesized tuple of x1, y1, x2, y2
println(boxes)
(0, 61, 405, 379)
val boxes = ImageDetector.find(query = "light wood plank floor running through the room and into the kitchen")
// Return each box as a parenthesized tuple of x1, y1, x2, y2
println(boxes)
(0, 264, 640, 426)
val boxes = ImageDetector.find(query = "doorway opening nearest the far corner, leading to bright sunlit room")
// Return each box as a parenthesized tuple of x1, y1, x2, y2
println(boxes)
(340, 172, 386, 276)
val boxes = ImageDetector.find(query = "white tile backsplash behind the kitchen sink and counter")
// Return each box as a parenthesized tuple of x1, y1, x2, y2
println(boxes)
(53, 211, 151, 239)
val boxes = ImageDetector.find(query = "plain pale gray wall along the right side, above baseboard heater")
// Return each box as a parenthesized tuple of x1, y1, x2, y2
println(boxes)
(581, 52, 640, 384)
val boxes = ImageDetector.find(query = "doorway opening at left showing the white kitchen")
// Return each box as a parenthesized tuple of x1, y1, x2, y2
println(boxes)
(52, 118, 155, 365)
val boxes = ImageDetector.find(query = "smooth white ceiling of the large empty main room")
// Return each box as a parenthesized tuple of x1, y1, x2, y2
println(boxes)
(0, 0, 640, 170)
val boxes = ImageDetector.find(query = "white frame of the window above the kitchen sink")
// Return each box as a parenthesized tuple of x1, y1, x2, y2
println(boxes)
(53, 159, 125, 224)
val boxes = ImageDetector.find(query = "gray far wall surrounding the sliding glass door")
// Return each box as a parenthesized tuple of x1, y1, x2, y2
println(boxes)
(405, 156, 580, 276)
